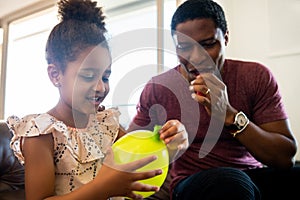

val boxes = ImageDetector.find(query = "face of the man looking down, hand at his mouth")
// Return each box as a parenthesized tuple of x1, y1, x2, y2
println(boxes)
(174, 19, 228, 81)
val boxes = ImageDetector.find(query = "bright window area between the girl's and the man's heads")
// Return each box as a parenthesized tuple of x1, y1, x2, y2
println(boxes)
(103, 0, 177, 128)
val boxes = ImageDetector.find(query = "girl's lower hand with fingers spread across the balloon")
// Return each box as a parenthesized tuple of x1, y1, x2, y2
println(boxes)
(95, 148, 162, 199)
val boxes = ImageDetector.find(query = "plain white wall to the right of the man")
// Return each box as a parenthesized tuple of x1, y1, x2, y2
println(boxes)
(217, 0, 300, 160)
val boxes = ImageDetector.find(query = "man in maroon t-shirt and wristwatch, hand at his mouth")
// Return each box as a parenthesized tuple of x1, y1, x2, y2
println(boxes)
(129, 0, 300, 200)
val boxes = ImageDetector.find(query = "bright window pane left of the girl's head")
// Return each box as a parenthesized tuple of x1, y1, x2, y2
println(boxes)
(4, 9, 58, 118)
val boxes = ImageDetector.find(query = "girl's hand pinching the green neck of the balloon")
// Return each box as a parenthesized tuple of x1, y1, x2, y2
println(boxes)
(159, 120, 189, 160)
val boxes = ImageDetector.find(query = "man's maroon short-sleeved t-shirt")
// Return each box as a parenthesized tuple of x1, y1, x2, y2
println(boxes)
(129, 59, 287, 194)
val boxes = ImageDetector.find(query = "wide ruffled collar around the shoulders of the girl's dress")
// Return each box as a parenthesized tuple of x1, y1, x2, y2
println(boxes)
(7, 109, 120, 164)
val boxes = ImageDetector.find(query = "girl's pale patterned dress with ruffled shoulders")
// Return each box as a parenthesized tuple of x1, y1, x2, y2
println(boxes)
(7, 109, 119, 195)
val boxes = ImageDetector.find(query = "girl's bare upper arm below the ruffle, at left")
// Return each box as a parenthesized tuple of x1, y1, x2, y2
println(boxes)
(22, 134, 55, 200)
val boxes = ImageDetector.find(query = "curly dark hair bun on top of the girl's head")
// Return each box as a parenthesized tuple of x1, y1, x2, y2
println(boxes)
(58, 0, 106, 30)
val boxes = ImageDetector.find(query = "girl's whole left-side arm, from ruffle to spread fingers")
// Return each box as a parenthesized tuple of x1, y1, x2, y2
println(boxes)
(23, 134, 162, 200)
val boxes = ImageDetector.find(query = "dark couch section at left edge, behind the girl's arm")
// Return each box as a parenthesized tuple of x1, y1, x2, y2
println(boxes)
(0, 121, 25, 200)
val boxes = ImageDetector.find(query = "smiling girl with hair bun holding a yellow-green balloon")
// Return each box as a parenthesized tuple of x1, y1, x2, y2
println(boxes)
(8, 0, 187, 200)
